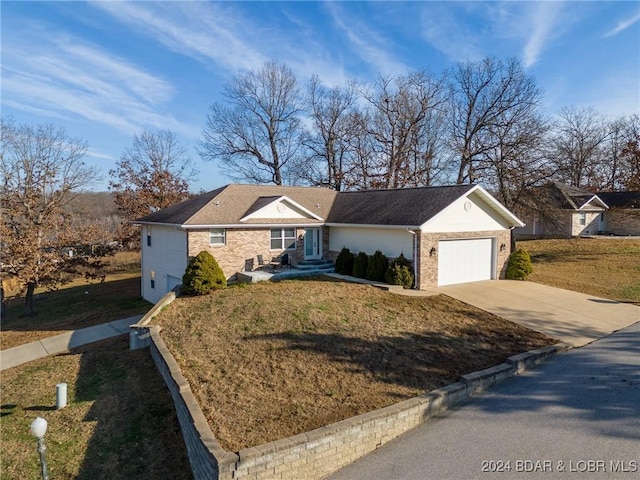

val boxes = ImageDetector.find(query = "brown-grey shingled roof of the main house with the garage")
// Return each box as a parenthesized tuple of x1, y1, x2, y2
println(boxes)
(137, 184, 488, 226)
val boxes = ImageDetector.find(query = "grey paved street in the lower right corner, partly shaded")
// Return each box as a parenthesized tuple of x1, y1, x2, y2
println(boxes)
(330, 323, 640, 480)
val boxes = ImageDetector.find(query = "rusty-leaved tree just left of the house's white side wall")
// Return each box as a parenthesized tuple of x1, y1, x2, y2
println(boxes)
(109, 130, 197, 246)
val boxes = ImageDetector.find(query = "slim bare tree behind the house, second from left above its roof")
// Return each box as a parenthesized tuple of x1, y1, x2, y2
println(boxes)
(297, 76, 360, 191)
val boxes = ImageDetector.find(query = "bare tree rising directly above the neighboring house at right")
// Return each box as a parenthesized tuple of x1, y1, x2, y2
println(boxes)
(551, 106, 609, 190)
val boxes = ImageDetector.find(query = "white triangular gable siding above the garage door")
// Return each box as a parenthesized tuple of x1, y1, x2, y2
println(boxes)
(422, 193, 508, 233)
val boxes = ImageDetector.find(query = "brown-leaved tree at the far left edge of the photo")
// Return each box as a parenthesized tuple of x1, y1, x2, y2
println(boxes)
(0, 119, 100, 315)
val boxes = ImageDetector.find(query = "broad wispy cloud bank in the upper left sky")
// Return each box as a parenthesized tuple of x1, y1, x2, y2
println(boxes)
(2, 22, 193, 137)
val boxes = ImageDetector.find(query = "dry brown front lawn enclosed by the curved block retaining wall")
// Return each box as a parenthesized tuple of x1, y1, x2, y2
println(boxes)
(157, 279, 554, 451)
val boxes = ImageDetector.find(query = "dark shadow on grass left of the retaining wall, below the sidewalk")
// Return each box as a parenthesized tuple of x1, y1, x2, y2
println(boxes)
(73, 336, 192, 480)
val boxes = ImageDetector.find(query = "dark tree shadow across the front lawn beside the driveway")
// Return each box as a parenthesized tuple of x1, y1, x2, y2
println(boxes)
(247, 326, 549, 390)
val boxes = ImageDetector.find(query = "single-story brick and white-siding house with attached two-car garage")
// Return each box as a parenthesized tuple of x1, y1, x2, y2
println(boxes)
(136, 184, 524, 302)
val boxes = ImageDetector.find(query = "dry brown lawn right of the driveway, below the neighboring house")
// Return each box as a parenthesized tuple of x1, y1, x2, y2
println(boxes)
(518, 238, 640, 304)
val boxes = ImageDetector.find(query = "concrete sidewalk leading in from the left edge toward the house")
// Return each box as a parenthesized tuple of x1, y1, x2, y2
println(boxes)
(0, 315, 142, 370)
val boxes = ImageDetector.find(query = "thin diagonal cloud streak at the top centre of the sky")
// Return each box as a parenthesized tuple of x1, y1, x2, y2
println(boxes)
(325, 2, 408, 74)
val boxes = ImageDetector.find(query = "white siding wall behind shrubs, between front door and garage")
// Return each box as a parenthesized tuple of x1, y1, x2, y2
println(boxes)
(329, 227, 413, 260)
